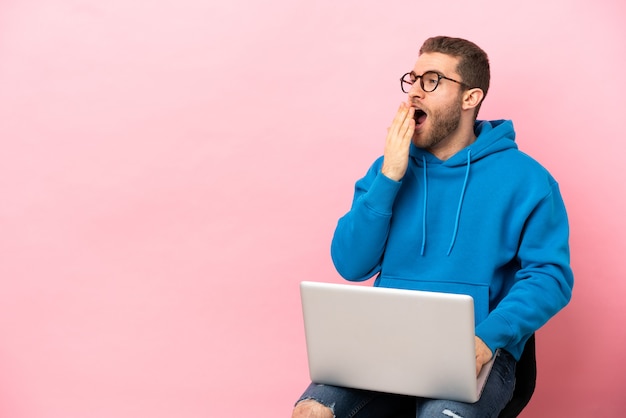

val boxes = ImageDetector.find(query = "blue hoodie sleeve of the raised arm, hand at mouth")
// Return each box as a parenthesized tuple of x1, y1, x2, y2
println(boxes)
(331, 157, 401, 281)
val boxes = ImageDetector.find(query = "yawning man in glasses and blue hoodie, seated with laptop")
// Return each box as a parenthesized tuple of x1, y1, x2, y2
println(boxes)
(293, 37, 573, 418)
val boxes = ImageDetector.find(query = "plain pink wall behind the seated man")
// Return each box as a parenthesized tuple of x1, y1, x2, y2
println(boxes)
(0, 0, 626, 418)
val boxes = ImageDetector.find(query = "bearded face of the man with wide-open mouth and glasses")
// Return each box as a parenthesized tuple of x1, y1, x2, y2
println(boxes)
(408, 53, 463, 150)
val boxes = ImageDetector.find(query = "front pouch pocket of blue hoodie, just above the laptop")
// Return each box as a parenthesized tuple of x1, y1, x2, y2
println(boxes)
(376, 277, 489, 325)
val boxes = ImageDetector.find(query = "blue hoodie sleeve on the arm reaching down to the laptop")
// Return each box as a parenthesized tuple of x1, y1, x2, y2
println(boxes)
(476, 182, 574, 351)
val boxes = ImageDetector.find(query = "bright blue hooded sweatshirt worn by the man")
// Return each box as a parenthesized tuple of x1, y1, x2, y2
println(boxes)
(331, 120, 574, 359)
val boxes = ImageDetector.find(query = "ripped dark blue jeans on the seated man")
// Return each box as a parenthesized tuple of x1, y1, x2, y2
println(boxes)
(298, 350, 516, 418)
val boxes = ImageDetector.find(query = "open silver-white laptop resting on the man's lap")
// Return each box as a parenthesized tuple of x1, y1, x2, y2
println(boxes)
(300, 281, 496, 402)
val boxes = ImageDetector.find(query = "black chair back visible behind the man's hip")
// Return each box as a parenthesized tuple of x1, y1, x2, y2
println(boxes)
(498, 334, 537, 418)
